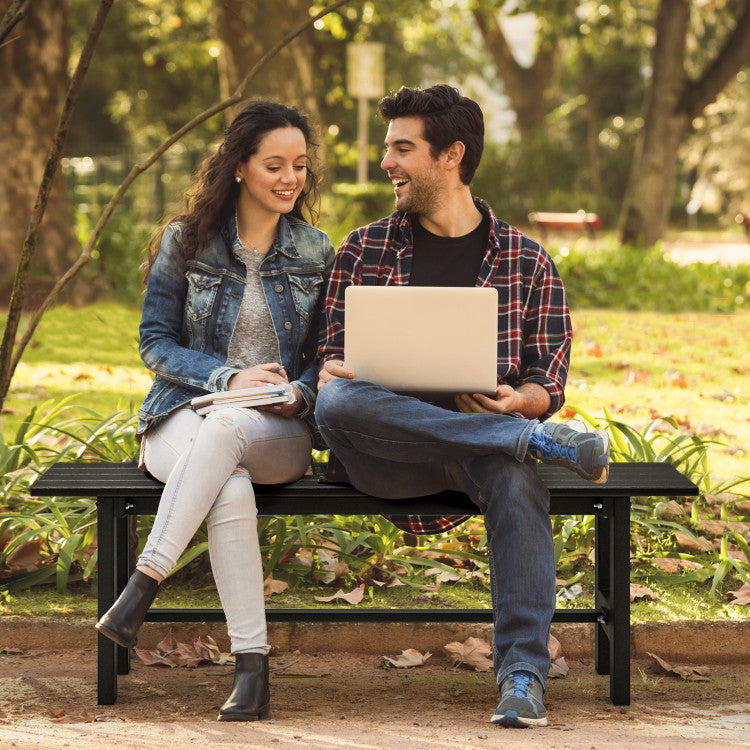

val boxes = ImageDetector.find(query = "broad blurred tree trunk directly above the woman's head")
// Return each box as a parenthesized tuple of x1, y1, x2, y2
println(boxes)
(214, 0, 322, 126)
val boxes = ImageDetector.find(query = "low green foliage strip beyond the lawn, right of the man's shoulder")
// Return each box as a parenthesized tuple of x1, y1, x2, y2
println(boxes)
(548, 240, 750, 313)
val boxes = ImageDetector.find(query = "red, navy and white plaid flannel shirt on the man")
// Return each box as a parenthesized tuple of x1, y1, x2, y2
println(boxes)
(318, 198, 572, 534)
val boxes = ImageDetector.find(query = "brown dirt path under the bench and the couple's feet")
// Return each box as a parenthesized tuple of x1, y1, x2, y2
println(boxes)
(0, 650, 750, 750)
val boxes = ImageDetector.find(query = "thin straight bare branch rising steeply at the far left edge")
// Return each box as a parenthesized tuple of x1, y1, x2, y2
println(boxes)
(0, 0, 114, 403)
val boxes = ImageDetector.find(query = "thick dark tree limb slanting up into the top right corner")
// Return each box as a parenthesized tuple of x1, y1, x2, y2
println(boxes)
(680, 0, 750, 119)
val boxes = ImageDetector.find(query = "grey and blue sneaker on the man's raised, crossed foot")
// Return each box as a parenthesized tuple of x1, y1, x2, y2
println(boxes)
(528, 419, 609, 484)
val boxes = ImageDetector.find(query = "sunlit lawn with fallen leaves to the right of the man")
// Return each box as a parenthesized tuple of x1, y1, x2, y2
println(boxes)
(561, 310, 750, 478)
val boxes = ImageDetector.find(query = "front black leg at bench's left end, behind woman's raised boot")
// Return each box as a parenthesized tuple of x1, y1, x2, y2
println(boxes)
(96, 498, 117, 706)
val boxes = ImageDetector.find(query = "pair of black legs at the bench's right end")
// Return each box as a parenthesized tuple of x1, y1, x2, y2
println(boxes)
(595, 498, 630, 706)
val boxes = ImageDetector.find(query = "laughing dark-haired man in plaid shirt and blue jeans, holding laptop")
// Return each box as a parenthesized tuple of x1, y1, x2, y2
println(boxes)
(316, 85, 609, 727)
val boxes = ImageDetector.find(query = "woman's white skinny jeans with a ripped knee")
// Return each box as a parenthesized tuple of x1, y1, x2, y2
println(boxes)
(138, 407, 312, 654)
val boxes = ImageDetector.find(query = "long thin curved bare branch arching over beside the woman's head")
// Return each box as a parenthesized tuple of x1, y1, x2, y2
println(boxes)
(2, 0, 351, 381)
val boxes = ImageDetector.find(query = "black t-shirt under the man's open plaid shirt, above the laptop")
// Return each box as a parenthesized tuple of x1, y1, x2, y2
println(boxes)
(409, 214, 490, 286)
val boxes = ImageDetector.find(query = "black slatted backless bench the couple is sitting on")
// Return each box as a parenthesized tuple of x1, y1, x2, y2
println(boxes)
(30, 463, 698, 705)
